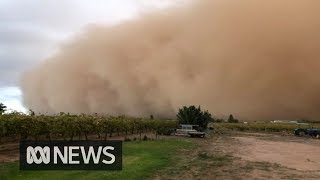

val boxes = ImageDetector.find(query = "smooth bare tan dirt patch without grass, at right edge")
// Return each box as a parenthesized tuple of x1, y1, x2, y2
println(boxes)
(234, 134, 320, 171)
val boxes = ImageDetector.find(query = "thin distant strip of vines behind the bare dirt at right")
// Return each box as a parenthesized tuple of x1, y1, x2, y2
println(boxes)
(209, 123, 320, 132)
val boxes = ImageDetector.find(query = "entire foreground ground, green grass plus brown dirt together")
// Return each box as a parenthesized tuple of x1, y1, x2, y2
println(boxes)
(0, 131, 320, 180)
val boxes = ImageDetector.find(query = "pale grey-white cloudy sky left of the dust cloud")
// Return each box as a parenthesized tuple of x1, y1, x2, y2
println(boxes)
(0, 0, 177, 112)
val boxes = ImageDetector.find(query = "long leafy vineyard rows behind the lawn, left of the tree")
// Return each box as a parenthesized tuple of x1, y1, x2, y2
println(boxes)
(0, 113, 177, 143)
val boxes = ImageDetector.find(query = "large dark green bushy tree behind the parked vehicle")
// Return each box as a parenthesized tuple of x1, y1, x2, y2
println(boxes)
(177, 106, 213, 129)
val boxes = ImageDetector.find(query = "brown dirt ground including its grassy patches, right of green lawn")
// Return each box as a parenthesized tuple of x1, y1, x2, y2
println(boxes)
(157, 132, 320, 180)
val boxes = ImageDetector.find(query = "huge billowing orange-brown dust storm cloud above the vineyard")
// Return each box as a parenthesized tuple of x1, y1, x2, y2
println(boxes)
(21, 0, 320, 120)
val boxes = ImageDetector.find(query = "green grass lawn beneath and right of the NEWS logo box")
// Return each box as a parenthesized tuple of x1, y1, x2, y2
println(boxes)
(0, 139, 194, 180)
